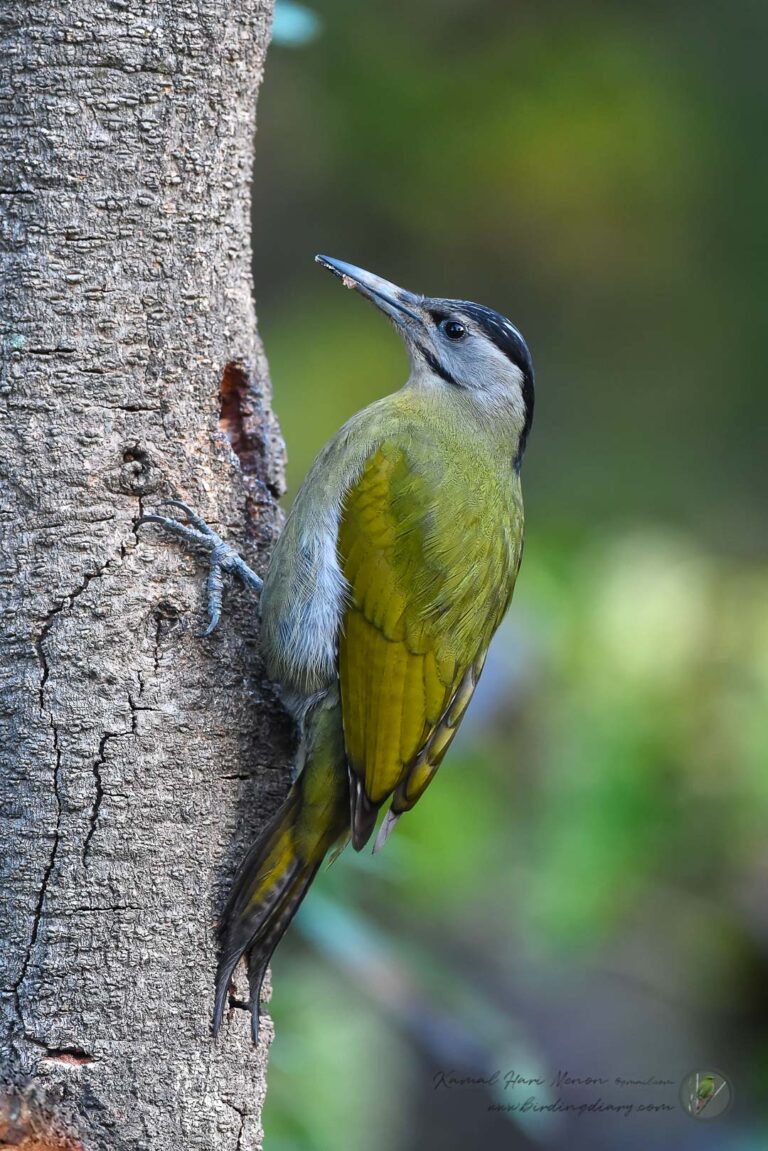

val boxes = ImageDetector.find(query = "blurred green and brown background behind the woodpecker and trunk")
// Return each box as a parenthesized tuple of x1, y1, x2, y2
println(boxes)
(249, 0, 768, 1151)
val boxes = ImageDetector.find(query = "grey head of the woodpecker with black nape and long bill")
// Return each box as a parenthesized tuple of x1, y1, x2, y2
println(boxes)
(315, 256, 534, 468)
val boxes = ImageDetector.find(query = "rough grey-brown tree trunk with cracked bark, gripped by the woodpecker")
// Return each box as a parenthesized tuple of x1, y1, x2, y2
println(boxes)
(0, 0, 291, 1151)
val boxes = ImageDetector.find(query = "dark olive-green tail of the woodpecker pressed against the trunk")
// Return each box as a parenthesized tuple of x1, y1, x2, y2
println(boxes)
(213, 706, 349, 1043)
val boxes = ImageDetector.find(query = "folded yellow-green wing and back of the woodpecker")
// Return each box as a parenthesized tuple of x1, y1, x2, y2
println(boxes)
(337, 440, 523, 848)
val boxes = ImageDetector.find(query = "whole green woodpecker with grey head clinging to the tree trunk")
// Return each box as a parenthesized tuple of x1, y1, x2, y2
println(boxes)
(143, 256, 534, 1042)
